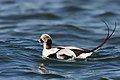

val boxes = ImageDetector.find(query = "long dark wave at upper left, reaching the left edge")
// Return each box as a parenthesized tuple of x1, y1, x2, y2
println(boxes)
(0, 13, 60, 20)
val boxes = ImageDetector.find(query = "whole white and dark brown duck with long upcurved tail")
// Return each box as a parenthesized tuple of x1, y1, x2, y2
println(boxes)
(38, 22, 116, 60)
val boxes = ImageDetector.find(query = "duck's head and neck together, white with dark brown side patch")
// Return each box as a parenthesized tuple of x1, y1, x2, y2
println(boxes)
(38, 34, 52, 49)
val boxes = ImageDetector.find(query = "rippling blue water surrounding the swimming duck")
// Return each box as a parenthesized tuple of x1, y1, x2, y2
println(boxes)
(0, 0, 120, 80)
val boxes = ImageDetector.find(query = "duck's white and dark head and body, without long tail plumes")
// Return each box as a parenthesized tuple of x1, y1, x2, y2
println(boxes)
(39, 34, 96, 60)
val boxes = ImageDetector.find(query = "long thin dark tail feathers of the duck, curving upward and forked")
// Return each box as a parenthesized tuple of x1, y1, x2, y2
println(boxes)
(90, 20, 117, 52)
